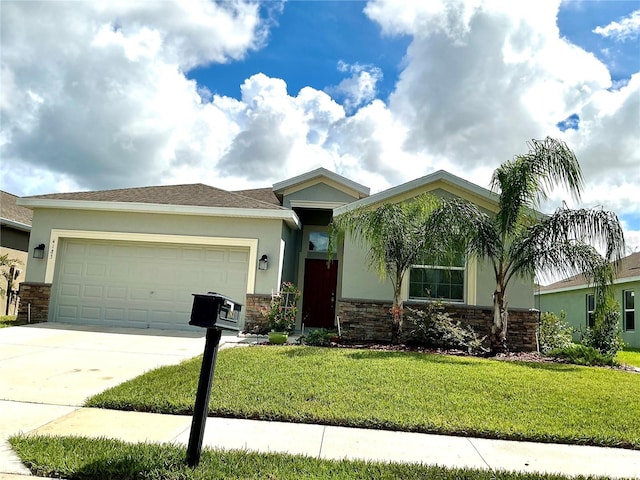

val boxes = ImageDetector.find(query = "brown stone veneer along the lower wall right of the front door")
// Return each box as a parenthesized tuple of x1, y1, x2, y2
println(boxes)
(338, 298, 538, 352)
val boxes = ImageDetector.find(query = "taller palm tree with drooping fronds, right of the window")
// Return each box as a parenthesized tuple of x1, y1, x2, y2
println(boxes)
(428, 137, 624, 353)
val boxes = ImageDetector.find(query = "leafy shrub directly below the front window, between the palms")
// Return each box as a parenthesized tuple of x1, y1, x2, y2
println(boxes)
(406, 302, 488, 355)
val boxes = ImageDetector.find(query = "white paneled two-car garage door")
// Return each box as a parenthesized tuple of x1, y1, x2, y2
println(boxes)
(52, 239, 249, 329)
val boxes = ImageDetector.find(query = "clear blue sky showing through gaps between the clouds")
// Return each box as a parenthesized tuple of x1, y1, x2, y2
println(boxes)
(188, 0, 640, 102)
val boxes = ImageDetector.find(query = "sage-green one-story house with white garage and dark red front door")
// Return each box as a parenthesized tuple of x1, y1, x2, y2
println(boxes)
(19, 168, 535, 345)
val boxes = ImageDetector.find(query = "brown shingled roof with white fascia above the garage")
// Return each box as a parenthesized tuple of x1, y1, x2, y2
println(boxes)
(18, 183, 300, 228)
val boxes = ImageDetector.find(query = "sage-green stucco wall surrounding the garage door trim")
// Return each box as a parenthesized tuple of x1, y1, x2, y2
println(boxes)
(27, 209, 283, 293)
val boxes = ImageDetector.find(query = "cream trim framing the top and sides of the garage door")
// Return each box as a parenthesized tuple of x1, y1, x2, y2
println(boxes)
(44, 229, 258, 293)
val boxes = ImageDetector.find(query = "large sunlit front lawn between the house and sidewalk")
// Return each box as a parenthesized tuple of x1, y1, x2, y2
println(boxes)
(87, 347, 640, 449)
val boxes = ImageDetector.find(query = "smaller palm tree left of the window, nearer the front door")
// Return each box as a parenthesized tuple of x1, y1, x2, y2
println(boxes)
(329, 194, 451, 343)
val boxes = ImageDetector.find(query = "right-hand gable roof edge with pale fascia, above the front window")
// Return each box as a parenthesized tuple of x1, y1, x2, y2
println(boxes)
(333, 170, 498, 215)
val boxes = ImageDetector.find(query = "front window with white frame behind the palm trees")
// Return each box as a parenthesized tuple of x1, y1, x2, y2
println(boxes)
(409, 252, 465, 302)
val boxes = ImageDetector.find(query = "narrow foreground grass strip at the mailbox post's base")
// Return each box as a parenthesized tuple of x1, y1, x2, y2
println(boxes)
(9, 436, 608, 480)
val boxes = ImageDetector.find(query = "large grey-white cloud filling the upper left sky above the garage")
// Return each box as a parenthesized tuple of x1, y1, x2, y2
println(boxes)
(0, 1, 265, 192)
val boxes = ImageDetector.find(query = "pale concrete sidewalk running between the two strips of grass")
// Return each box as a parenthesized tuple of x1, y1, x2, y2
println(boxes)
(0, 402, 640, 478)
